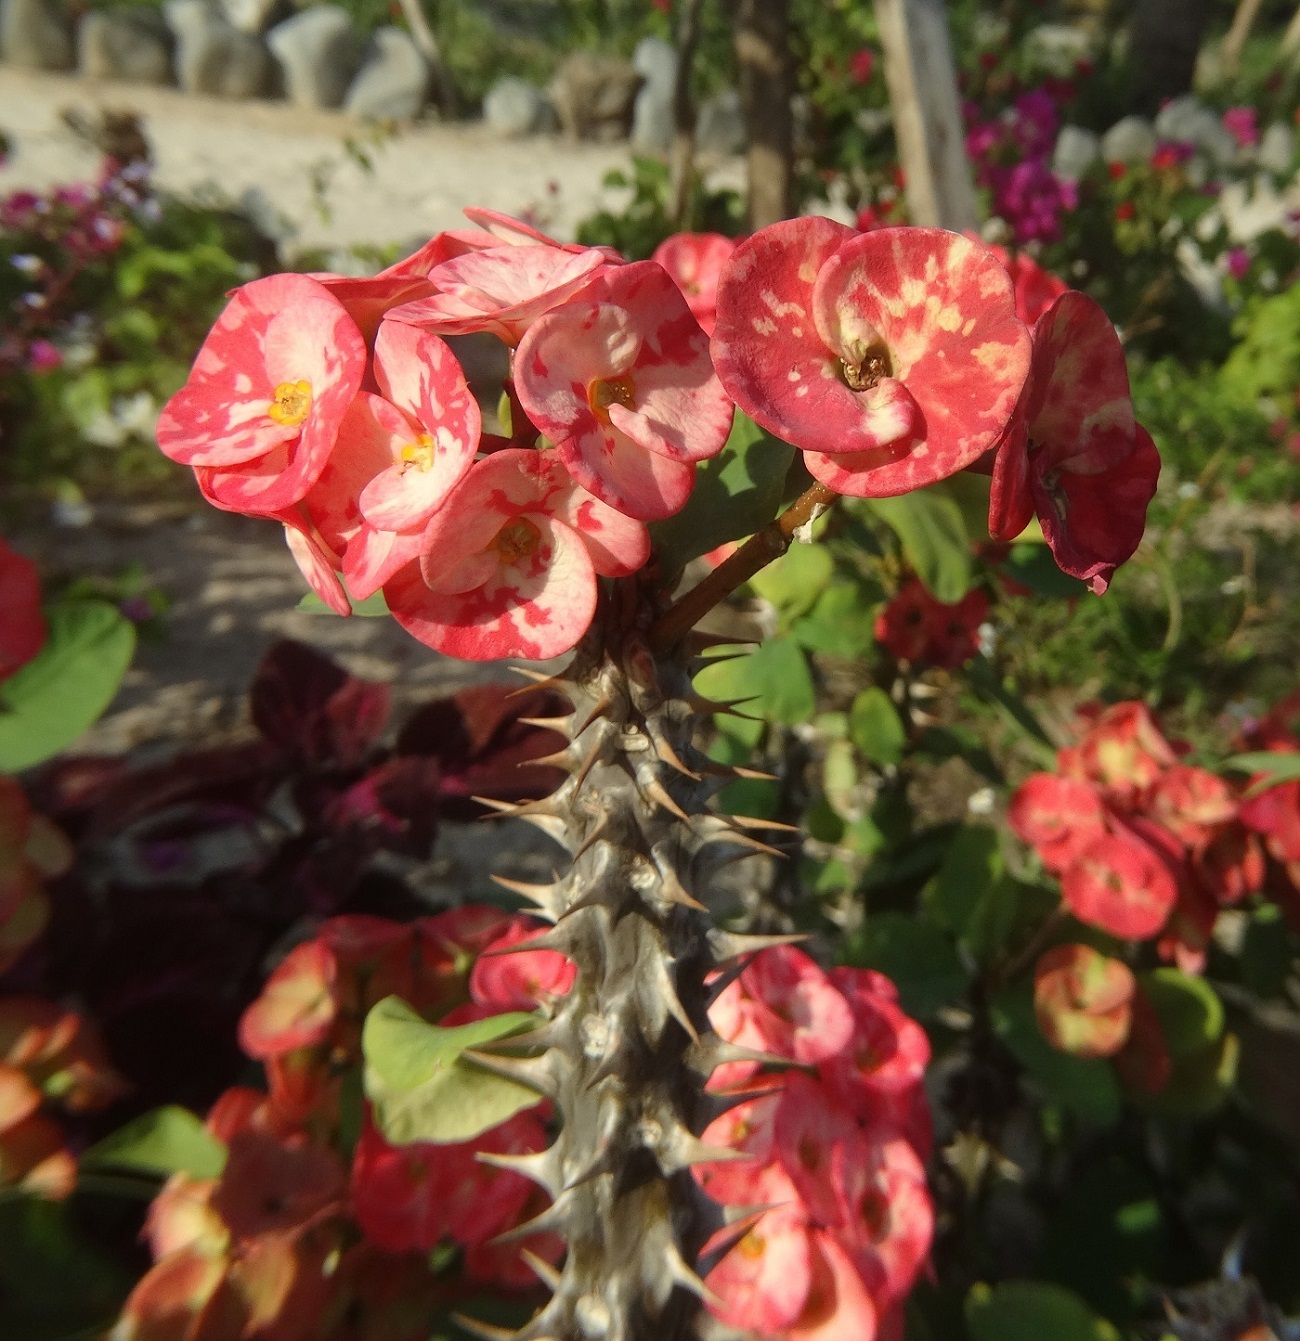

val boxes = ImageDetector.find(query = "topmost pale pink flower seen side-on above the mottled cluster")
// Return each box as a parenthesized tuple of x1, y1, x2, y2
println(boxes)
(389, 247, 609, 345)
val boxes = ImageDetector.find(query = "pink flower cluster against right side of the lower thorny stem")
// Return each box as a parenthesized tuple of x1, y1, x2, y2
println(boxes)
(699, 948, 934, 1341)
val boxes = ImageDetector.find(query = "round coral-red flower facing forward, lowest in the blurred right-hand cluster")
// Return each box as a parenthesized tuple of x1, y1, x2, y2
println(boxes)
(1061, 830, 1178, 940)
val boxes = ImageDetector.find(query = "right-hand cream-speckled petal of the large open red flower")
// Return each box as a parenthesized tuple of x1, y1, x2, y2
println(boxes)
(797, 228, 1030, 498)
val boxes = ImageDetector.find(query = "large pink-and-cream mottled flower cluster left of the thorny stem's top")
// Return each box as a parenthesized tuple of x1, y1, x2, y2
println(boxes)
(158, 212, 733, 660)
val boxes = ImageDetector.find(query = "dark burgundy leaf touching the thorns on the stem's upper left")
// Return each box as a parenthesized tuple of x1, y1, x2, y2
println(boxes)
(397, 684, 572, 819)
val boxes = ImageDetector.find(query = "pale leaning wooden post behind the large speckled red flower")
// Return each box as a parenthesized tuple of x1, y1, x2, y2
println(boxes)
(876, 0, 979, 232)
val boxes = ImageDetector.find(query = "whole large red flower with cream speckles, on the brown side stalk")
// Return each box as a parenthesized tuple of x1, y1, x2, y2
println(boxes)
(712, 219, 1030, 498)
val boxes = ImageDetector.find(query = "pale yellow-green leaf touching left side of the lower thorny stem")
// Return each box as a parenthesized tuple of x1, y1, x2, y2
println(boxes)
(361, 996, 541, 1145)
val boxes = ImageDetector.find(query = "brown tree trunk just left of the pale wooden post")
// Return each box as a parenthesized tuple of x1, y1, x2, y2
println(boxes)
(735, 0, 794, 231)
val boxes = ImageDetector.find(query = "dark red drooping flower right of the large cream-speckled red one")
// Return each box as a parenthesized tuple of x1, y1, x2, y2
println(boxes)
(989, 291, 1160, 594)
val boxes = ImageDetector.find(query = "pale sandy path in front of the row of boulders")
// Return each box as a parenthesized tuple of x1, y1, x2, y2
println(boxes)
(0, 66, 660, 245)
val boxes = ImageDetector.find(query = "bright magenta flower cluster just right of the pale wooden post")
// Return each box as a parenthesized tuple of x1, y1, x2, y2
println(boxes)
(966, 87, 1079, 244)
